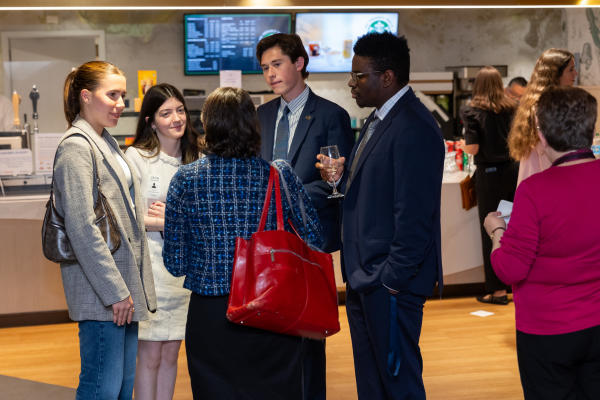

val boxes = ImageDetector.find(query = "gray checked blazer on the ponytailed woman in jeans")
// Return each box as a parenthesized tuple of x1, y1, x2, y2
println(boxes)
(54, 116, 156, 321)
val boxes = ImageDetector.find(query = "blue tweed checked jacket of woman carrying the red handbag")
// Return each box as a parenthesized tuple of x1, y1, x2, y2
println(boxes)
(163, 155, 323, 296)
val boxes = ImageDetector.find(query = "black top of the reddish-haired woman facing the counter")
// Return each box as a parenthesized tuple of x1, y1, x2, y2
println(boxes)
(460, 106, 514, 164)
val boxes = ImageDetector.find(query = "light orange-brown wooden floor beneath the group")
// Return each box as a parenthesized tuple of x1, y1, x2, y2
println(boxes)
(0, 298, 523, 400)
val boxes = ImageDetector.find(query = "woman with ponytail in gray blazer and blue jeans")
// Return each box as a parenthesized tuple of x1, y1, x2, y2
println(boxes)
(54, 61, 156, 400)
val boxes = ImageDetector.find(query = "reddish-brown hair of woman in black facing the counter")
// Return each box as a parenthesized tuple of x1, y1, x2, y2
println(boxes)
(470, 66, 517, 114)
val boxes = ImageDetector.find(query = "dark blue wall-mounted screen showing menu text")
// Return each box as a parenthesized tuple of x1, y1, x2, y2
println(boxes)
(184, 14, 292, 75)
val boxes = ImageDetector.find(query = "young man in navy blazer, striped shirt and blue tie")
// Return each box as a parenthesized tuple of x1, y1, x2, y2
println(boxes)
(256, 34, 354, 400)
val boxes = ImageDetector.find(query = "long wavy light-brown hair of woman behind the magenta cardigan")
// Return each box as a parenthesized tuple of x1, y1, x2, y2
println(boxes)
(508, 48, 573, 161)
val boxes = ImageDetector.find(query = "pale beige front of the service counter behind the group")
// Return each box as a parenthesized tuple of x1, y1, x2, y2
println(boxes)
(0, 172, 484, 324)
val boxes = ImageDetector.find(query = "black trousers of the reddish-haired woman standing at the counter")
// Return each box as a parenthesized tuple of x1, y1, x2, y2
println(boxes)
(475, 161, 519, 292)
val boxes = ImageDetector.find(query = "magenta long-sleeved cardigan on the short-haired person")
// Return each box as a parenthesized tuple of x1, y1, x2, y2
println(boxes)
(491, 160, 600, 335)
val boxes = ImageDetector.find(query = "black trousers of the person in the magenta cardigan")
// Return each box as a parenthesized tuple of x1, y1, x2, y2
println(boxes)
(517, 325, 600, 400)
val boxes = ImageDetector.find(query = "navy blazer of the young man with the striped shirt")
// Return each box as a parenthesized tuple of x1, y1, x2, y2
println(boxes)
(257, 89, 354, 253)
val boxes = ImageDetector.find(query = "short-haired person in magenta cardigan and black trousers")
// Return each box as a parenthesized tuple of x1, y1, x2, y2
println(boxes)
(485, 85, 600, 400)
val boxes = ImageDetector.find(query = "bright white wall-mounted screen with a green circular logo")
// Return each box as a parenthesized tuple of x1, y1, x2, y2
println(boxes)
(296, 13, 398, 72)
